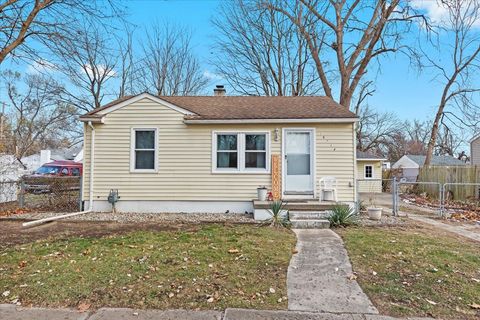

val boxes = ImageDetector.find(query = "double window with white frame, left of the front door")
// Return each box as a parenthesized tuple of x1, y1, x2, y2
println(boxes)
(212, 132, 270, 173)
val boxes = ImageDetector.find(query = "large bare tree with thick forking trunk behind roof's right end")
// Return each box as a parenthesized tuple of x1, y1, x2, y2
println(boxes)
(263, 0, 423, 108)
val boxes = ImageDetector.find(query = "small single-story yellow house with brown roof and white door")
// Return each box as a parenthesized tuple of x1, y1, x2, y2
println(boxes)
(80, 93, 357, 218)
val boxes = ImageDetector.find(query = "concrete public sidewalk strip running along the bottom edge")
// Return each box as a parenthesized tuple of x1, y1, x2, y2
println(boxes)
(0, 304, 436, 320)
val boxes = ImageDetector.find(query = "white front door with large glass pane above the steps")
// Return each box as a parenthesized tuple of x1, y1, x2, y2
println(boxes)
(283, 129, 315, 196)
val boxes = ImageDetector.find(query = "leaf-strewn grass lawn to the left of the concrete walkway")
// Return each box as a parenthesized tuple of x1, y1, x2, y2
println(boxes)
(0, 225, 295, 309)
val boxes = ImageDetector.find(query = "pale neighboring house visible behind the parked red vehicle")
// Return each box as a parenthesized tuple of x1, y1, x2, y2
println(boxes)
(21, 145, 83, 171)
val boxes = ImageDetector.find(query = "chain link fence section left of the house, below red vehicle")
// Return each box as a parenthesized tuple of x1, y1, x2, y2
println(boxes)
(0, 177, 82, 215)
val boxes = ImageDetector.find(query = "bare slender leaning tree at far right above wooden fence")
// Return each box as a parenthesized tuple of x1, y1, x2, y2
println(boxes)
(425, 0, 480, 165)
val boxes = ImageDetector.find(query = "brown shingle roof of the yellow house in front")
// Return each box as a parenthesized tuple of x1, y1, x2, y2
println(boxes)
(80, 96, 357, 120)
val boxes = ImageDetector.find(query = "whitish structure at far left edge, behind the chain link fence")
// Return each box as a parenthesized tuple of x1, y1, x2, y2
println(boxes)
(0, 154, 25, 203)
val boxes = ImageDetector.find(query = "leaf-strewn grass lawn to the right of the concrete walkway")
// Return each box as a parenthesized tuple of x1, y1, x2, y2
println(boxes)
(338, 226, 480, 319)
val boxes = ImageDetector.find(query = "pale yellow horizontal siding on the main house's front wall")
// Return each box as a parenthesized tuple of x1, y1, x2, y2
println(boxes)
(83, 99, 354, 201)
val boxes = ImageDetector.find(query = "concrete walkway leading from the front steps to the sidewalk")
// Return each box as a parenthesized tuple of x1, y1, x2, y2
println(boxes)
(287, 229, 378, 314)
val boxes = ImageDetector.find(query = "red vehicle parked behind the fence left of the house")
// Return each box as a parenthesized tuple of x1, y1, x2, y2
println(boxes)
(23, 160, 83, 193)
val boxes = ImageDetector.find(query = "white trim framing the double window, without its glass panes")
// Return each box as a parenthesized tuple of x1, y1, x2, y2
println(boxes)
(212, 130, 271, 174)
